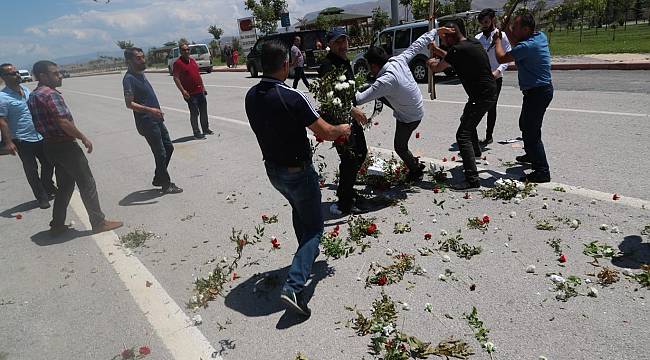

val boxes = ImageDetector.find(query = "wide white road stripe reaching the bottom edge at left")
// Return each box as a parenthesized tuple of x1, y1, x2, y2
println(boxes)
(70, 191, 222, 360)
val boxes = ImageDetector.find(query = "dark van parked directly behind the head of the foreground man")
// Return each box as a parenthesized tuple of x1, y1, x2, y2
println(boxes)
(246, 30, 327, 77)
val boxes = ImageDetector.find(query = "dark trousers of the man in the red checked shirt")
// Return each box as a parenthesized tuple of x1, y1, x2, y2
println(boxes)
(44, 140, 105, 229)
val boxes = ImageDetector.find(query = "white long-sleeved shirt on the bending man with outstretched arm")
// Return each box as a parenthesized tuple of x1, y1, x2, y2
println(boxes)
(356, 29, 436, 123)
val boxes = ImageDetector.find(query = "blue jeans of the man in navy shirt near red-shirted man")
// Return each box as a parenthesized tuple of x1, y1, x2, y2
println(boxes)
(135, 121, 174, 187)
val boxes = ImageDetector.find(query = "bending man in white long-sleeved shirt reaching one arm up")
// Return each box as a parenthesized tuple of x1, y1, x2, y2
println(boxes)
(356, 28, 451, 181)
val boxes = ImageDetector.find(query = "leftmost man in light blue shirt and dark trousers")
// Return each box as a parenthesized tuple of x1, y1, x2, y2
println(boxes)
(0, 64, 56, 209)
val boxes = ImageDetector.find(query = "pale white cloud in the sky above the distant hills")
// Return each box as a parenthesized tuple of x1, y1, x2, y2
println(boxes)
(6, 0, 354, 66)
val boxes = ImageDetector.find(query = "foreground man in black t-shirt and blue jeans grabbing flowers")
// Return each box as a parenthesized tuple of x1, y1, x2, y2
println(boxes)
(246, 41, 350, 316)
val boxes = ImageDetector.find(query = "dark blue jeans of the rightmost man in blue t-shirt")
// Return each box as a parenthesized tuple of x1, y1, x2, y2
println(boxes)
(519, 84, 553, 175)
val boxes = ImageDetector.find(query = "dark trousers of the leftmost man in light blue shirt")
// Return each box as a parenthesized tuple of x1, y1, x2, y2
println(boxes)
(13, 139, 56, 201)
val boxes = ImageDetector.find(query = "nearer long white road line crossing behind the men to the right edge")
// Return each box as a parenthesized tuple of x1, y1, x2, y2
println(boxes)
(66, 90, 650, 209)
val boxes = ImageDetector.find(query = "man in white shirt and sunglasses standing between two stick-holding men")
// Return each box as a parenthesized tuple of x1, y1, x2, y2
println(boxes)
(475, 8, 510, 147)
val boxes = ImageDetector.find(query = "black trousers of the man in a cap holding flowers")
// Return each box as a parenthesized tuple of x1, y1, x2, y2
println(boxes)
(336, 122, 368, 212)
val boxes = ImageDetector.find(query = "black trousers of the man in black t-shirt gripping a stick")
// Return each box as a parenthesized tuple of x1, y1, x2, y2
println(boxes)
(456, 100, 496, 182)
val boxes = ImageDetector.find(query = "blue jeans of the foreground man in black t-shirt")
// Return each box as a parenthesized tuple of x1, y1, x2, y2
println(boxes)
(264, 161, 323, 293)
